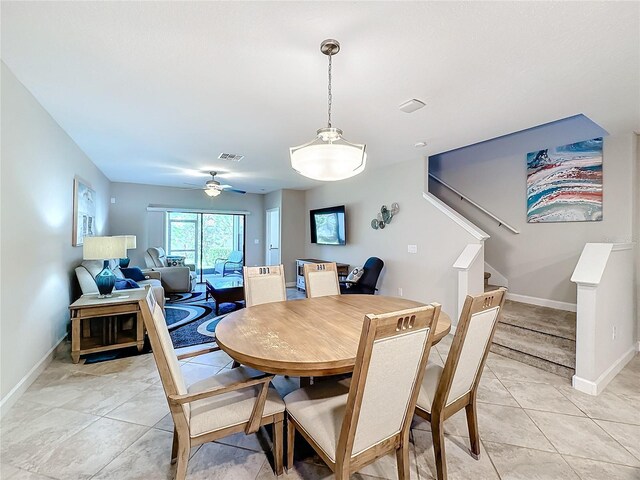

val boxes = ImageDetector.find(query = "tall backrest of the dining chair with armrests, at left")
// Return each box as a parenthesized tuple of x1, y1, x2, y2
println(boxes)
(140, 287, 190, 421)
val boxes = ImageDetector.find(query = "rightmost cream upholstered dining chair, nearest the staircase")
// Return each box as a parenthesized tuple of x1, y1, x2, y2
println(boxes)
(416, 288, 507, 480)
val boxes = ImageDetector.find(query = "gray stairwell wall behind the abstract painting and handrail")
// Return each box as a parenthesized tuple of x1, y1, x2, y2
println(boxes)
(429, 134, 635, 303)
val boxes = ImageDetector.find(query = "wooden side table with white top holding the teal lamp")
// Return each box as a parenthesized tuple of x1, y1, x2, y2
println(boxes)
(69, 289, 147, 363)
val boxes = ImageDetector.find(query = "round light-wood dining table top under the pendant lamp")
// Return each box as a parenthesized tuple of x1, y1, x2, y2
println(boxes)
(216, 295, 451, 377)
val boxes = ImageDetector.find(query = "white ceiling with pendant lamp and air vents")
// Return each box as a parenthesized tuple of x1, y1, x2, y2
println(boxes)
(1, 1, 640, 193)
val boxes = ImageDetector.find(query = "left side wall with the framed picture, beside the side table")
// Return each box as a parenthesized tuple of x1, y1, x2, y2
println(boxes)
(0, 63, 109, 413)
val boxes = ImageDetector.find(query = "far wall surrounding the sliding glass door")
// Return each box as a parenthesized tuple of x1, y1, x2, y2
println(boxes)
(109, 183, 264, 267)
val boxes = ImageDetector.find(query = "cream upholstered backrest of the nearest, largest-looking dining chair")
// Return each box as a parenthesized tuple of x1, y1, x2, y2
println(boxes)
(336, 304, 440, 462)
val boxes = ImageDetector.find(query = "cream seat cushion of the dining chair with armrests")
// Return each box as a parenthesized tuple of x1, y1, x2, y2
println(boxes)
(188, 367, 284, 436)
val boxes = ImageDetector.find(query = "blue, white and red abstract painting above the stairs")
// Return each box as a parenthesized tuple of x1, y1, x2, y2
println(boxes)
(527, 138, 602, 223)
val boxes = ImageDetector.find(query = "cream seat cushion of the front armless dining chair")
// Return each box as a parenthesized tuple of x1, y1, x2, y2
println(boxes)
(284, 379, 351, 461)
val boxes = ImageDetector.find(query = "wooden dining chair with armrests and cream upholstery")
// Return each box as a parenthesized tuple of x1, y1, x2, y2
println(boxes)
(141, 286, 284, 480)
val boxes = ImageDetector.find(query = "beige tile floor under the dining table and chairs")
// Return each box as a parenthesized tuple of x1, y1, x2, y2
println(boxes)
(0, 336, 640, 480)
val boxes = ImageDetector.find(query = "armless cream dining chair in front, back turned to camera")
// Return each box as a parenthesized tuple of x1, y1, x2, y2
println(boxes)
(284, 304, 440, 480)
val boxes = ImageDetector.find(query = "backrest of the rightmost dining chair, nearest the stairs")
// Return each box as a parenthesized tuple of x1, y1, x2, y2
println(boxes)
(432, 288, 507, 409)
